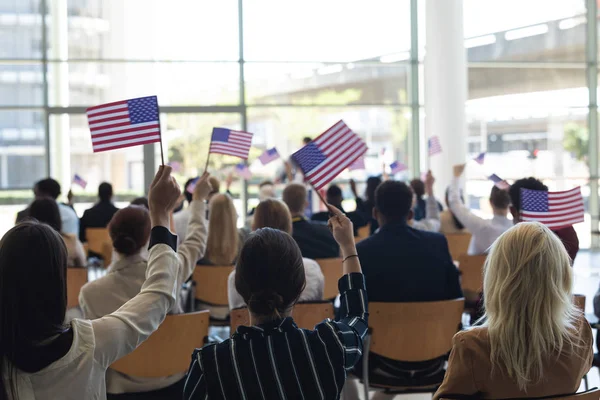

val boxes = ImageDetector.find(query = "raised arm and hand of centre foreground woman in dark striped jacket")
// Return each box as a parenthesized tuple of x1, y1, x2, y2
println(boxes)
(317, 205, 369, 370)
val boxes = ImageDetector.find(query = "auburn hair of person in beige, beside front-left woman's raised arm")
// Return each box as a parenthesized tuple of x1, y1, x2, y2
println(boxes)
(108, 205, 150, 256)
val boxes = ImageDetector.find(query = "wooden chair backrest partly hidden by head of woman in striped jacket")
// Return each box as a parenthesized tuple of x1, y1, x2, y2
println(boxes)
(229, 301, 334, 334)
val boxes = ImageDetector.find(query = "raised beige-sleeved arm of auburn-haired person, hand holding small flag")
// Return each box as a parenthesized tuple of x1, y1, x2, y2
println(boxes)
(175, 172, 212, 307)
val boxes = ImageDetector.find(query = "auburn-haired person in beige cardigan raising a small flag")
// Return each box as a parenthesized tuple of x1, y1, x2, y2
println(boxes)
(79, 174, 211, 394)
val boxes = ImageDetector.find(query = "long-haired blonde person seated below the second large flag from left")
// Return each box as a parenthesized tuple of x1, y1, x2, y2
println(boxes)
(196, 194, 243, 319)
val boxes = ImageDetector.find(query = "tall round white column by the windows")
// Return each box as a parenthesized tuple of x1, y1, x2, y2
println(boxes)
(423, 0, 467, 197)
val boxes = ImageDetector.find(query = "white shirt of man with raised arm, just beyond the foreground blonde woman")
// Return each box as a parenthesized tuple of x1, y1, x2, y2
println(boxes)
(448, 178, 513, 255)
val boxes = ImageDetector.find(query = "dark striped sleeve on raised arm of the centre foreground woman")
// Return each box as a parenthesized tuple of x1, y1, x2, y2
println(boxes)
(317, 273, 369, 370)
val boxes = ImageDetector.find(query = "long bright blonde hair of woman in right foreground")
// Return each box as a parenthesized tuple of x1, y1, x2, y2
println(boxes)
(483, 222, 581, 391)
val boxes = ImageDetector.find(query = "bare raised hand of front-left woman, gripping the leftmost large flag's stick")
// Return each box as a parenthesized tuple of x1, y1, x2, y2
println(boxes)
(148, 165, 181, 228)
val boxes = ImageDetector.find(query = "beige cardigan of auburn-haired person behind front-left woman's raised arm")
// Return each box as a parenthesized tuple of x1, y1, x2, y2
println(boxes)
(79, 201, 207, 394)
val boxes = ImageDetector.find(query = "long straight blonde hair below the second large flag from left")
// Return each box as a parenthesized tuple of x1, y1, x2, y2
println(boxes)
(205, 194, 240, 265)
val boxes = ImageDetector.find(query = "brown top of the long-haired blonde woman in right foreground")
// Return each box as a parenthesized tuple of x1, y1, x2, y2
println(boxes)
(433, 318, 594, 400)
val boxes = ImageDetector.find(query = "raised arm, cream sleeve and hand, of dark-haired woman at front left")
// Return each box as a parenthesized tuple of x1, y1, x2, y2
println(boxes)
(92, 166, 181, 367)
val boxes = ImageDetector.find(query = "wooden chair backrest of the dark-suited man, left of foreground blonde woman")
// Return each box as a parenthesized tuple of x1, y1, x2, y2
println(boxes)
(369, 298, 465, 362)
